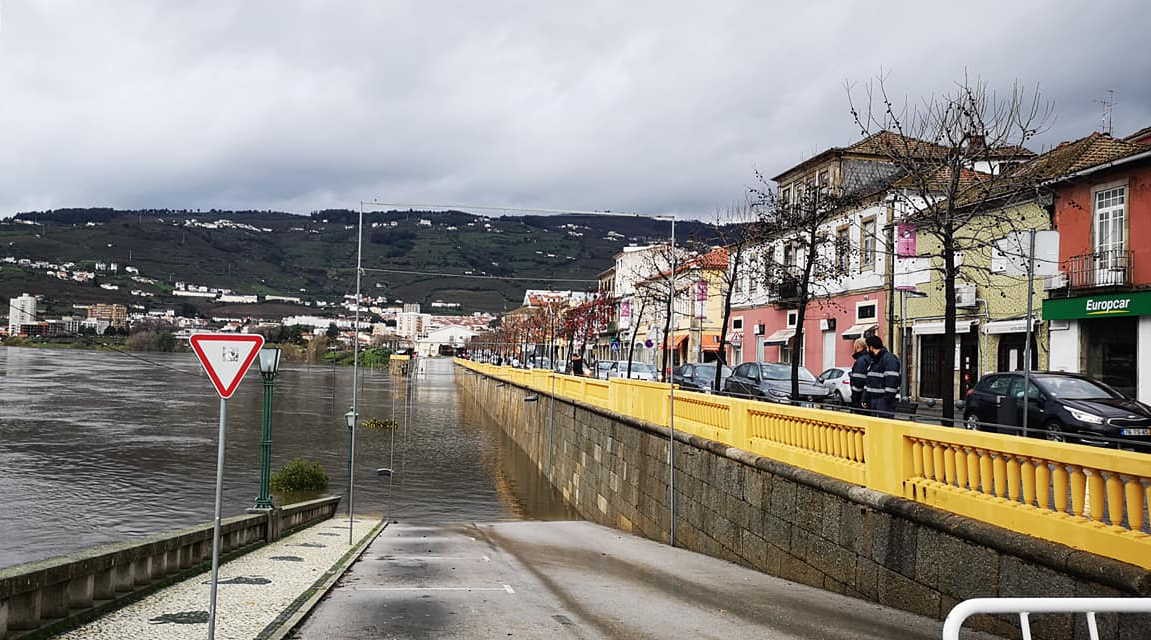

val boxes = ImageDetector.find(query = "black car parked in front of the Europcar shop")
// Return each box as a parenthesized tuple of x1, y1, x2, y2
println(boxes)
(963, 372, 1151, 450)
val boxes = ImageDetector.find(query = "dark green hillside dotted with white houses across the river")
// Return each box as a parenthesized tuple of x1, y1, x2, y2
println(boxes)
(0, 208, 712, 311)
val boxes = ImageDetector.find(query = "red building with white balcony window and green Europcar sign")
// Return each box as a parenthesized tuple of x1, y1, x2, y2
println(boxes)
(1043, 134, 1151, 403)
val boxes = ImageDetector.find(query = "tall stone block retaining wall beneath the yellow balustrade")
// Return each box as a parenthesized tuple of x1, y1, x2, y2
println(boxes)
(456, 368, 1151, 640)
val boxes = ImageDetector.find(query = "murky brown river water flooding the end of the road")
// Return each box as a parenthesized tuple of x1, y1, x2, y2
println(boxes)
(0, 348, 573, 567)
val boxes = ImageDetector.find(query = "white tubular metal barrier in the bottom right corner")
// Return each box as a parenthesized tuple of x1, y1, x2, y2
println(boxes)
(943, 597, 1151, 640)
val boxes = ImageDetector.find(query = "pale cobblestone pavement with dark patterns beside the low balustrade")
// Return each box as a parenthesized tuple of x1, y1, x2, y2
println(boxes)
(59, 516, 380, 640)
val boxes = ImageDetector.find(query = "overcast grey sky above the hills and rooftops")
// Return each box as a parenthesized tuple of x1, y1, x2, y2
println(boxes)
(0, 0, 1151, 218)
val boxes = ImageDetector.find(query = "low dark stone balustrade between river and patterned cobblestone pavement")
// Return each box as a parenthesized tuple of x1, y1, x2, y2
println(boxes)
(0, 496, 340, 640)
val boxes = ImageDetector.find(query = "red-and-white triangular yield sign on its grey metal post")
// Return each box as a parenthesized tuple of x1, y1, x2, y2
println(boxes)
(189, 334, 264, 640)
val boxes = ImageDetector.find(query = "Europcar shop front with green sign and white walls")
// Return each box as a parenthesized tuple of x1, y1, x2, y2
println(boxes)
(1043, 291, 1151, 402)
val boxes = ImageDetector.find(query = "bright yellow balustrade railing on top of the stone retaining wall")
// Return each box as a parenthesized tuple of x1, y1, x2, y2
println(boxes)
(457, 360, 1151, 569)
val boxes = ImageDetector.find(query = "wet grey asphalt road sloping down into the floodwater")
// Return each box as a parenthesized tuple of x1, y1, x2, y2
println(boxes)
(292, 521, 989, 640)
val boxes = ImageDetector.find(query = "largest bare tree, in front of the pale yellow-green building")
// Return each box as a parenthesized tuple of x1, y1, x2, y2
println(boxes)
(848, 77, 1053, 421)
